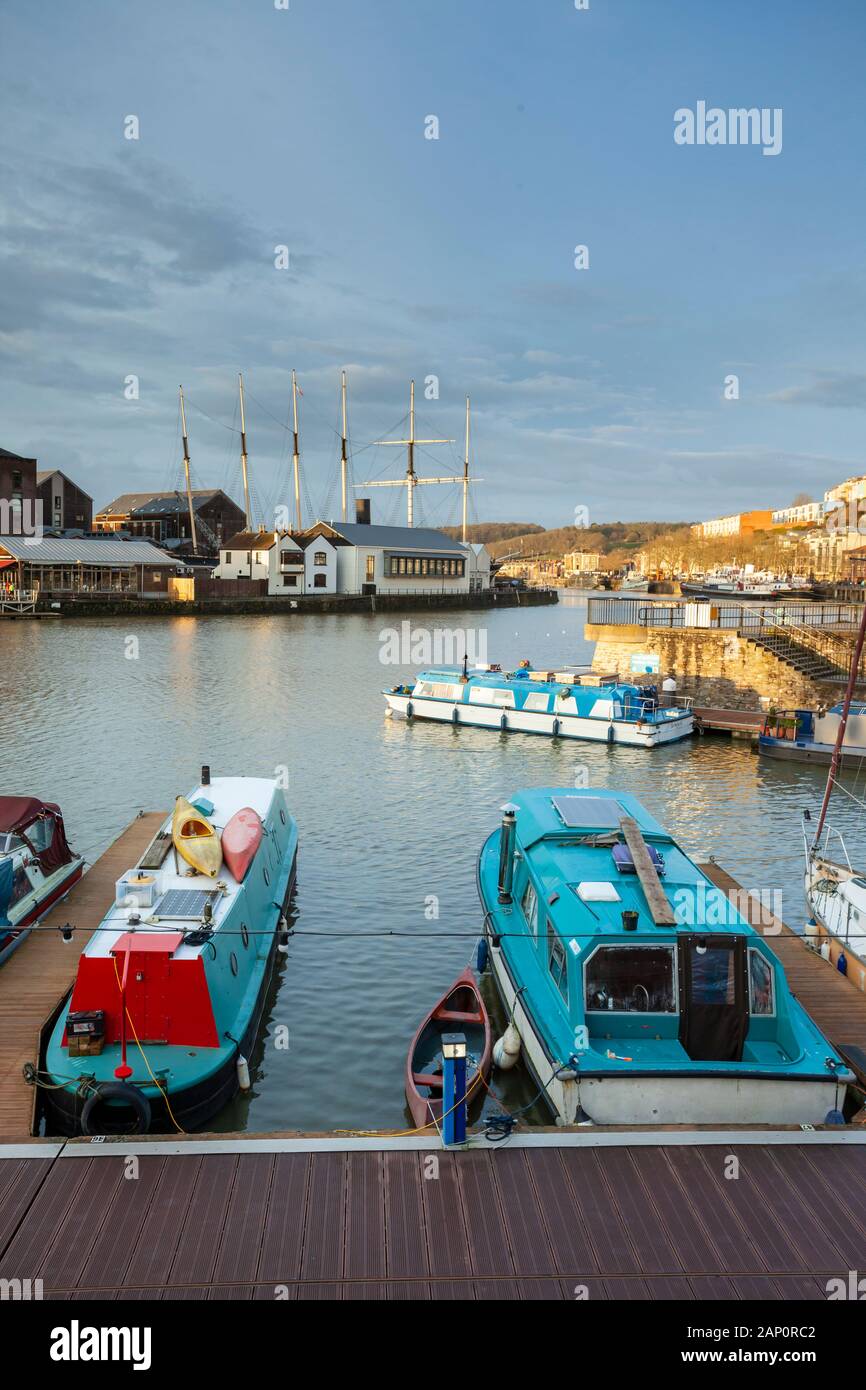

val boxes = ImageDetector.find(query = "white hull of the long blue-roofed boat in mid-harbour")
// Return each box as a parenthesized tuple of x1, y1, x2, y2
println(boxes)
(385, 694, 694, 748)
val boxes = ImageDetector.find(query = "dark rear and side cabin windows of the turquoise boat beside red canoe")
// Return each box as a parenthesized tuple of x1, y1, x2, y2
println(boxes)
(521, 881, 776, 1017)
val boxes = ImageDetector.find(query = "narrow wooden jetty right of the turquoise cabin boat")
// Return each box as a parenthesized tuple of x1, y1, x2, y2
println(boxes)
(701, 863, 866, 1086)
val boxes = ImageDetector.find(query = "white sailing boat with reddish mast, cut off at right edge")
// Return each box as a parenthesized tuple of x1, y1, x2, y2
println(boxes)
(803, 605, 866, 990)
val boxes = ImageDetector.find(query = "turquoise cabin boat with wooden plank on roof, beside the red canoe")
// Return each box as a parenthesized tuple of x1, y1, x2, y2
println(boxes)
(478, 788, 853, 1125)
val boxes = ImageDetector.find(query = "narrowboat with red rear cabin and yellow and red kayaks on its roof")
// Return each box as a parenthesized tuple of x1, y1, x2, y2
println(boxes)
(43, 769, 297, 1134)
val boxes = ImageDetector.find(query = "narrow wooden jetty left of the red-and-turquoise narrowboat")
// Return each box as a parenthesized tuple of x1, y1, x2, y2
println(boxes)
(0, 812, 165, 1138)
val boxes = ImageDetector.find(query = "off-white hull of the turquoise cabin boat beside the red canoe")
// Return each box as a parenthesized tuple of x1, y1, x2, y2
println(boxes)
(488, 937, 845, 1125)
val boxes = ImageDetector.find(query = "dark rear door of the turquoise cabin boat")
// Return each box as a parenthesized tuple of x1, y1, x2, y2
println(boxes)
(677, 931, 749, 1062)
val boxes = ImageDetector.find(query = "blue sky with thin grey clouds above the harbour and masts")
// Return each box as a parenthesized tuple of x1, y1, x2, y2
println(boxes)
(0, 0, 866, 527)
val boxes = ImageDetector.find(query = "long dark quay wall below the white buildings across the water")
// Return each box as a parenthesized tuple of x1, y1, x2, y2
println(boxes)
(38, 589, 559, 617)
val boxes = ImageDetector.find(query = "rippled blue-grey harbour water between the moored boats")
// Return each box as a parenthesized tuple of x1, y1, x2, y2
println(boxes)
(0, 595, 866, 1131)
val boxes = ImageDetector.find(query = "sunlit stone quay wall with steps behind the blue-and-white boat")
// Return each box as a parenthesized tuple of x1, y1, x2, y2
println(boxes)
(585, 623, 840, 709)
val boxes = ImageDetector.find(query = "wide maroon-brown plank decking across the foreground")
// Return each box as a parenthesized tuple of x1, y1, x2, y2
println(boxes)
(0, 1131, 866, 1301)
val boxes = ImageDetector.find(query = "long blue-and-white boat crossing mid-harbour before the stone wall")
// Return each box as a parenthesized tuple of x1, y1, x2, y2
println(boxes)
(382, 662, 694, 748)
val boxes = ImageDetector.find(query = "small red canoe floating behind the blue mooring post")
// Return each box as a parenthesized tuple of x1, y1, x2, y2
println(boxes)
(406, 967, 492, 1133)
